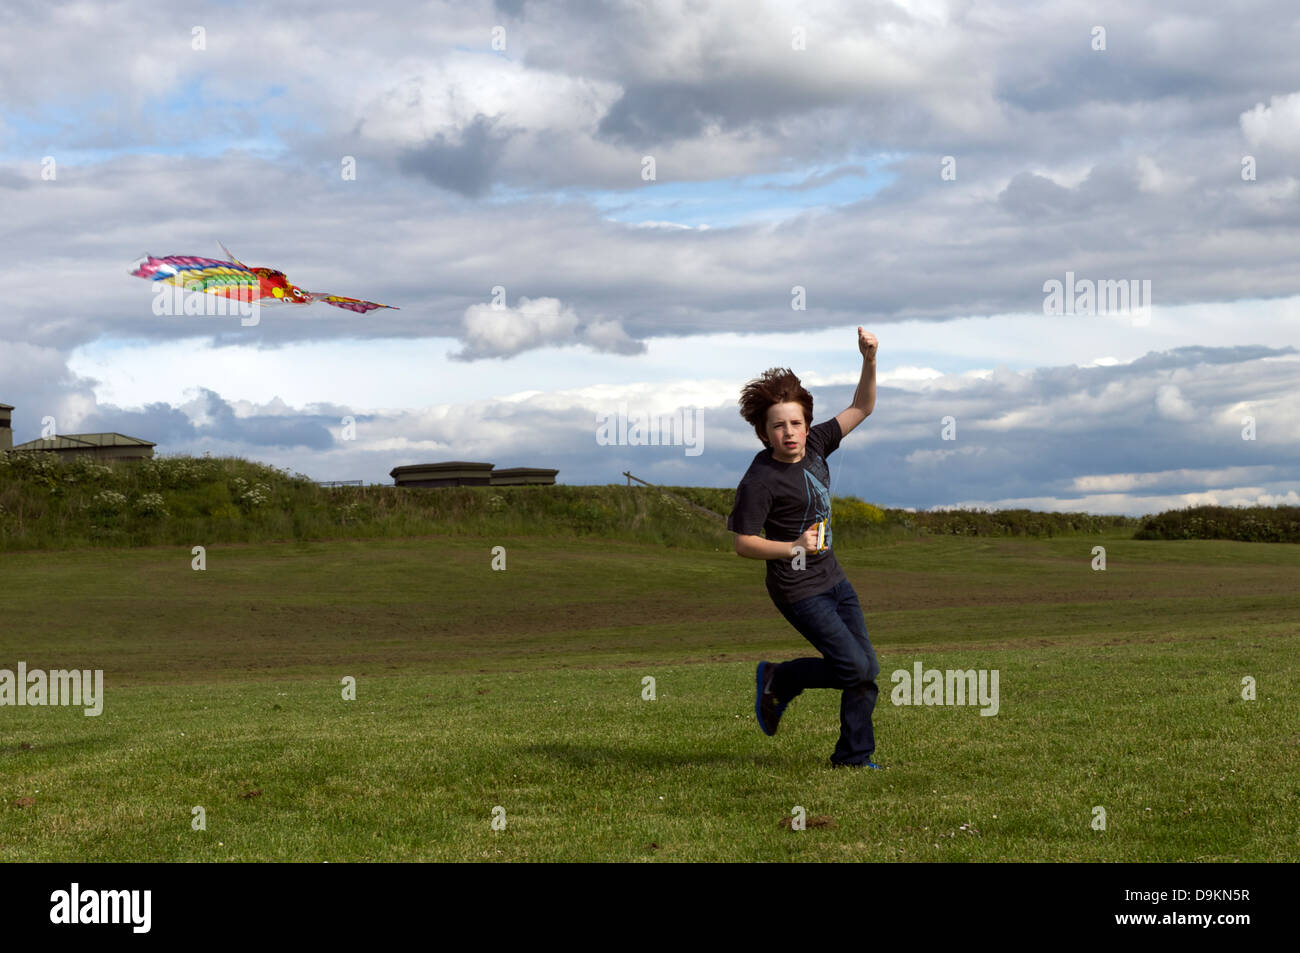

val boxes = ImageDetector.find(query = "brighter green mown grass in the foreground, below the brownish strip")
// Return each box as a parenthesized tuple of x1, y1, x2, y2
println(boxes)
(0, 647, 1300, 862)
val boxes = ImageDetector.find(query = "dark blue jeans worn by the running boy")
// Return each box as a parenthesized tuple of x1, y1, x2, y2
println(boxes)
(772, 580, 880, 764)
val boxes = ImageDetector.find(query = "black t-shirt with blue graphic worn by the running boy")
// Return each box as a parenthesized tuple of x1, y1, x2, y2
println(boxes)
(727, 417, 845, 603)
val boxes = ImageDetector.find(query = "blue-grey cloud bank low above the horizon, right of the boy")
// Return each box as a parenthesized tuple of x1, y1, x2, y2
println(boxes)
(811, 348, 1300, 514)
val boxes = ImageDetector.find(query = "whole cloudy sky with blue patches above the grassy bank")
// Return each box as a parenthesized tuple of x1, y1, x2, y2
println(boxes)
(0, 0, 1300, 515)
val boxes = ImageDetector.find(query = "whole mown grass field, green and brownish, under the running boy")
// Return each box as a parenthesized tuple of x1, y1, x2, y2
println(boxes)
(0, 534, 1300, 862)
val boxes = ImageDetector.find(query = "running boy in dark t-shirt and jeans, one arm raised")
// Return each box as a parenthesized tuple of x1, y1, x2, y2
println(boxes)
(727, 328, 880, 768)
